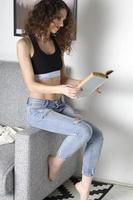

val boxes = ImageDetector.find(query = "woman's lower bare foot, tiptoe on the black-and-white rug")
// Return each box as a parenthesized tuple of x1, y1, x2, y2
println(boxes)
(75, 181, 89, 200)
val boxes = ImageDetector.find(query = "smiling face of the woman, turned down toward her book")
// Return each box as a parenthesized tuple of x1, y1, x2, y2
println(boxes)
(49, 9, 67, 33)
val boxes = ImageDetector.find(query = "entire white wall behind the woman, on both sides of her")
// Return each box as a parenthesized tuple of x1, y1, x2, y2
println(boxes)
(0, 0, 133, 185)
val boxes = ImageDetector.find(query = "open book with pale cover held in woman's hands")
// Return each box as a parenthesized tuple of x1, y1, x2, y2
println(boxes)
(77, 70, 113, 97)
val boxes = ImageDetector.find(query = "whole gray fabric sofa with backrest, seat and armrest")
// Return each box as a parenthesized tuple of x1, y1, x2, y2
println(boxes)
(0, 61, 80, 200)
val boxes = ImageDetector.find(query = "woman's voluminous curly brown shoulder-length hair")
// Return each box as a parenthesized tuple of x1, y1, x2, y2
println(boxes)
(22, 0, 75, 52)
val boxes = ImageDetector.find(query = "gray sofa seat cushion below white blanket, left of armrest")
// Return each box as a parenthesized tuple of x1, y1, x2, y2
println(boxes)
(0, 143, 14, 196)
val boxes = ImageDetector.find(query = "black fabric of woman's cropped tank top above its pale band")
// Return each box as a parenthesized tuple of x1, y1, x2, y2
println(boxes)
(29, 36, 62, 74)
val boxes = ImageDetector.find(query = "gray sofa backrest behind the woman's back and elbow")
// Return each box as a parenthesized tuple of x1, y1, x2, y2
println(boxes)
(0, 61, 28, 128)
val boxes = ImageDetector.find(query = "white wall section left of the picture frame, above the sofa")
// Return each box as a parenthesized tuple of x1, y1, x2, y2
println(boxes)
(0, 0, 18, 61)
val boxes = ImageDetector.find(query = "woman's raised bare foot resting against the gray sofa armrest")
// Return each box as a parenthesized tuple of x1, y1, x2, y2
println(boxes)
(48, 155, 61, 181)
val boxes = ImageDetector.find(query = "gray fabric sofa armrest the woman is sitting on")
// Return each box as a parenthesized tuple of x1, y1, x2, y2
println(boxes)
(14, 128, 79, 200)
